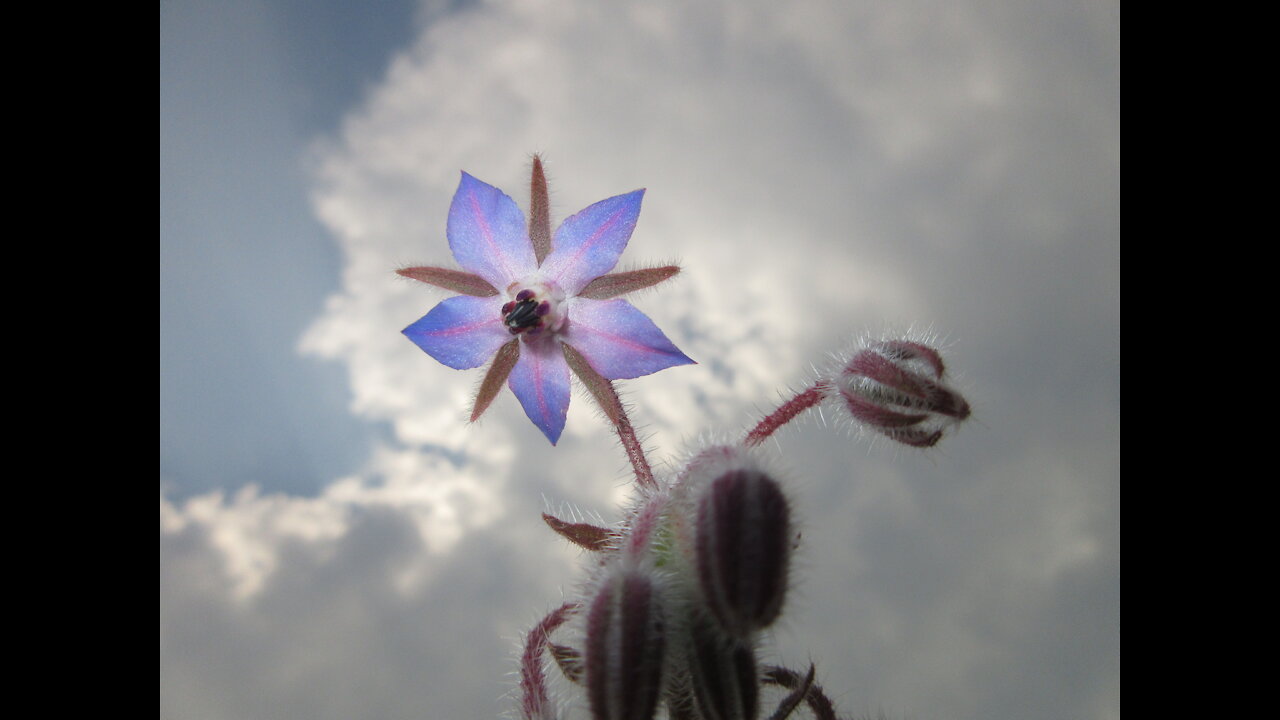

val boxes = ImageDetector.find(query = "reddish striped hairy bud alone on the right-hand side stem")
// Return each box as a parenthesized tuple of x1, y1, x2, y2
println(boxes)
(833, 341, 969, 447)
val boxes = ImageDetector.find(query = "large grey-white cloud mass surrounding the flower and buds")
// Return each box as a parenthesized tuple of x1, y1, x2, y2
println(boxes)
(161, 0, 1119, 720)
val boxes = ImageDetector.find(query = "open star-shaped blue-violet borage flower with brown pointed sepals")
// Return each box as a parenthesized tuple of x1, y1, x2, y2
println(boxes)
(399, 158, 692, 445)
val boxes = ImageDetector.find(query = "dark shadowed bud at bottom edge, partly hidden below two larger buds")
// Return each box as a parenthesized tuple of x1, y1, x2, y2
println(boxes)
(689, 609, 760, 720)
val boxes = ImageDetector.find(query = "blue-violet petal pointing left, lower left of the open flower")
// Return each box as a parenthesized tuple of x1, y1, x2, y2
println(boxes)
(403, 296, 511, 370)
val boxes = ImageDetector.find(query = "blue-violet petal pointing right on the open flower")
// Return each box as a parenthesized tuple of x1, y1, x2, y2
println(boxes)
(561, 297, 692, 380)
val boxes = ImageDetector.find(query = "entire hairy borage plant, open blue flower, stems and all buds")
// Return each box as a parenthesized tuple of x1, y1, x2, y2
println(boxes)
(409, 155, 969, 720)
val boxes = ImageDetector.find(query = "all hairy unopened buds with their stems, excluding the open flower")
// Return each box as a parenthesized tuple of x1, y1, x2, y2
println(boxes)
(521, 340, 969, 720)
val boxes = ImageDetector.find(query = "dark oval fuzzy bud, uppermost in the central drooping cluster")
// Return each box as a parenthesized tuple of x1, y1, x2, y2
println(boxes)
(695, 466, 791, 641)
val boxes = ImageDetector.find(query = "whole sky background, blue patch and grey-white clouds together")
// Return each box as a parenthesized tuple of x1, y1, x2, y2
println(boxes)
(160, 0, 1120, 720)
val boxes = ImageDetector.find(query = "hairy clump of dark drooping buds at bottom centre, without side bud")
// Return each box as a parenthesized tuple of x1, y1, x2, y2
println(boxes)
(524, 446, 795, 720)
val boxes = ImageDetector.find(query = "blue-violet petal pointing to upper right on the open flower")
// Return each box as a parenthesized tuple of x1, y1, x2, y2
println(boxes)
(543, 190, 644, 296)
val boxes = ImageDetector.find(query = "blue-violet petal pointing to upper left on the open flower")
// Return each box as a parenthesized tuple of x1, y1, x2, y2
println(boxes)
(445, 173, 538, 292)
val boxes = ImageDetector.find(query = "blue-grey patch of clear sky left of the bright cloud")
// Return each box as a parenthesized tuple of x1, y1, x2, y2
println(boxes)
(160, 1, 417, 497)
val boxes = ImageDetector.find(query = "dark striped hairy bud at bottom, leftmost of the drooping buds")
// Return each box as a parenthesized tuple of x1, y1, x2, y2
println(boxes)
(586, 568, 666, 720)
